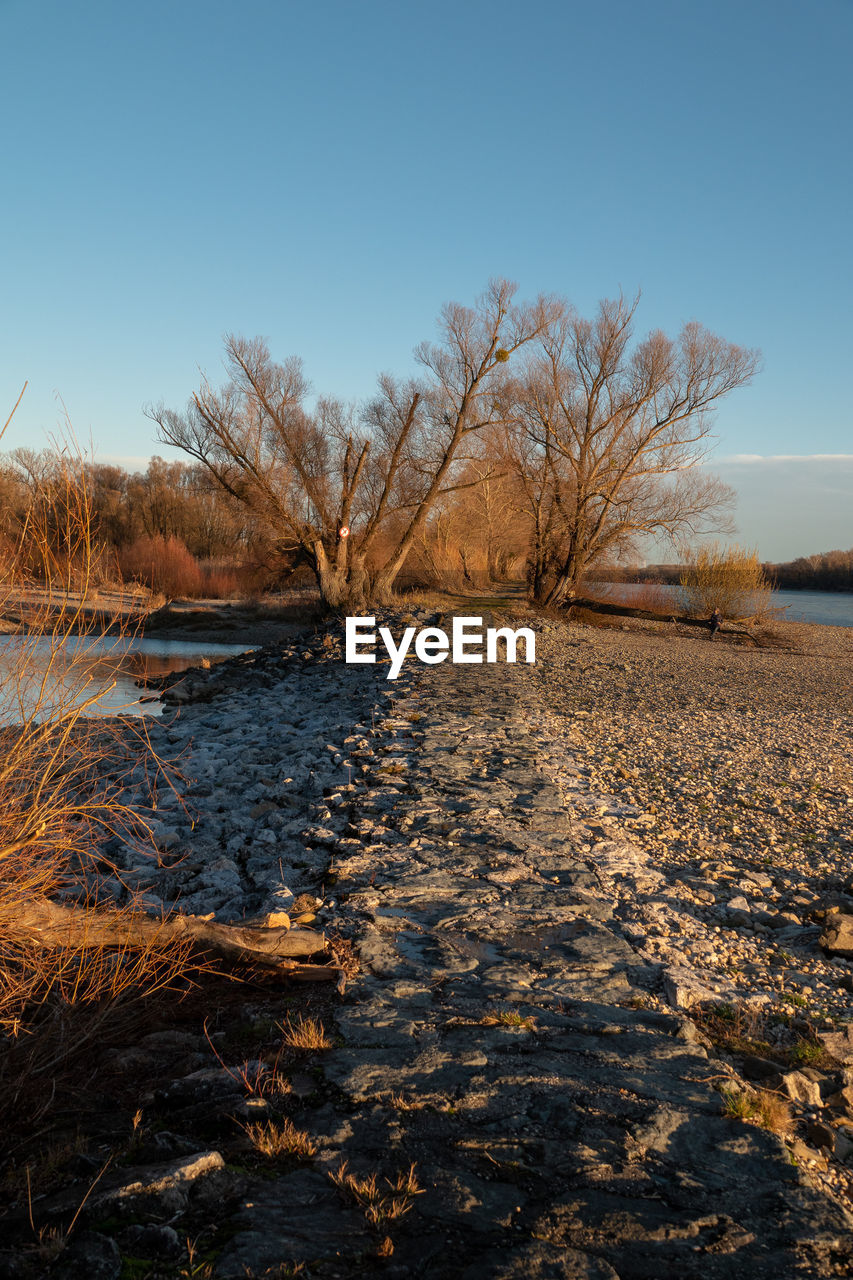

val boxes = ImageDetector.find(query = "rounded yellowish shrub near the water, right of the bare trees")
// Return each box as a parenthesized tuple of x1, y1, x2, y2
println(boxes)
(681, 543, 772, 618)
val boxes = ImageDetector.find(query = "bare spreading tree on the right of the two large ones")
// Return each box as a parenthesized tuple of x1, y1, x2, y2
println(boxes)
(516, 298, 758, 603)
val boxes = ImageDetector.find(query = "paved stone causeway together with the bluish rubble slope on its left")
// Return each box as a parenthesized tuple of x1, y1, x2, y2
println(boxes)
(6, 614, 853, 1280)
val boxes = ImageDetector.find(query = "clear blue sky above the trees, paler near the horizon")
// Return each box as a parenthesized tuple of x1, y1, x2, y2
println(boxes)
(0, 0, 853, 558)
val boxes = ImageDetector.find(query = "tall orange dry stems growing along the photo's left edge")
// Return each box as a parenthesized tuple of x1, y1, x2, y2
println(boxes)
(0, 399, 197, 1124)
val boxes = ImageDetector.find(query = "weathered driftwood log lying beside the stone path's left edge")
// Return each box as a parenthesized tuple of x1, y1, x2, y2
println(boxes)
(3, 899, 341, 980)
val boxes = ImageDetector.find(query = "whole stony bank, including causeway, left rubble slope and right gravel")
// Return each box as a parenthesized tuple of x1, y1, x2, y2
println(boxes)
(1, 611, 853, 1280)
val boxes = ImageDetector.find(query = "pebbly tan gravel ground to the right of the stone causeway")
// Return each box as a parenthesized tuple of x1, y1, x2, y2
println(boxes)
(516, 609, 853, 1203)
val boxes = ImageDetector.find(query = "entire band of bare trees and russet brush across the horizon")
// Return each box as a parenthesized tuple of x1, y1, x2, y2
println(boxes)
(0, 280, 853, 608)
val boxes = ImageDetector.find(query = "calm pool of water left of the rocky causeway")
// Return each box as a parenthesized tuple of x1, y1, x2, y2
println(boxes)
(0, 635, 251, 724)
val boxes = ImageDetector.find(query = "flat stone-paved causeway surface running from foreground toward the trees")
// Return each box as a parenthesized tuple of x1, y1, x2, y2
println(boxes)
(294, 666, 853, 1280)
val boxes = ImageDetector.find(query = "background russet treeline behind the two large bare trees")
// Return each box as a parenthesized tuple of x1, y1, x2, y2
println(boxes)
(0, 449, 853, 595)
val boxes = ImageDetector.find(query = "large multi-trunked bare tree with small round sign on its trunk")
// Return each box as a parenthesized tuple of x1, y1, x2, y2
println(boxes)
(147, 280, 558, 608)
